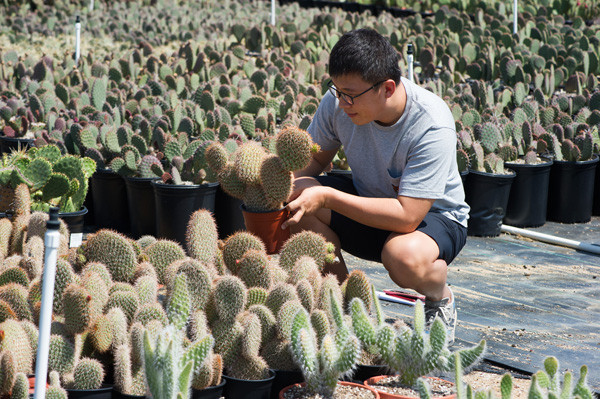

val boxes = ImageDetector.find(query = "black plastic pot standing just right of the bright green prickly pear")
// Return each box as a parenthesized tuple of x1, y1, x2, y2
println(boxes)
(92, 169, 129, 234)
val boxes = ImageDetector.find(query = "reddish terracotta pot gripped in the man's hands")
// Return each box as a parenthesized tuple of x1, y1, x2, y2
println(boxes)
(241, 204, 290, 254)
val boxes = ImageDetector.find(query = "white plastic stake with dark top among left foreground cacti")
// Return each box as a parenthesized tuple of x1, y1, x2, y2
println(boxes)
(33, 208, 60, 399)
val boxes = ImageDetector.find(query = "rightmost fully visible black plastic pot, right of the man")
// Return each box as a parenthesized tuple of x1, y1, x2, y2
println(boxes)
(547, 155, 600, 223)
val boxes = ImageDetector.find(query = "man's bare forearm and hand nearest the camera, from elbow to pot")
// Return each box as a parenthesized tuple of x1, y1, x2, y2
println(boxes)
(284, 186, 435, 233)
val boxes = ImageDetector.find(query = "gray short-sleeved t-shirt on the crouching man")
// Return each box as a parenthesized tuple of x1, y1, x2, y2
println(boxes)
(308, 78, 469, 227)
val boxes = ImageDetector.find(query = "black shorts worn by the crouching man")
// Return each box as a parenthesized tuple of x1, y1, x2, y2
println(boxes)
(317, 176, 467, 264)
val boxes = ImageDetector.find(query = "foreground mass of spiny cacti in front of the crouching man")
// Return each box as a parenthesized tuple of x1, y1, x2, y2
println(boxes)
(0, 203, 591, 398)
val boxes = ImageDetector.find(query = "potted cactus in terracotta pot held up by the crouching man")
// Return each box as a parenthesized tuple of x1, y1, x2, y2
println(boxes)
(206, 126, 316, 253)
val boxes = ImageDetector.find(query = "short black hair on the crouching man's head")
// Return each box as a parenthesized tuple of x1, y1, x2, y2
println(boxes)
(329, 28, 400, 84)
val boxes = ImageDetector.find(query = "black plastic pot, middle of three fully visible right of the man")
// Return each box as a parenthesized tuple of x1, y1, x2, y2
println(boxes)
(502, 160, 552, 227)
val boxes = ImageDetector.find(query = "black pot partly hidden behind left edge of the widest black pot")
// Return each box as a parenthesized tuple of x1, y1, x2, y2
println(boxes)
(124, 177, 156, 239)
